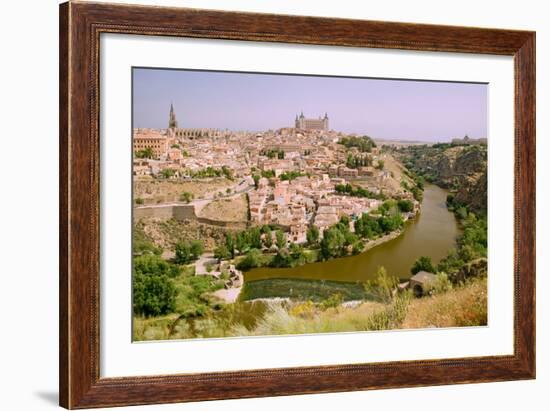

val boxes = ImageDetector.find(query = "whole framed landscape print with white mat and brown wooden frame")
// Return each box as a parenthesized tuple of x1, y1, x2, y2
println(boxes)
(60, 2, 535, 408)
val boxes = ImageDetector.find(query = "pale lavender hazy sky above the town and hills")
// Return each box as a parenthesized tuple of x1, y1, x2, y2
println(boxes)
(133, 68, 487, 142)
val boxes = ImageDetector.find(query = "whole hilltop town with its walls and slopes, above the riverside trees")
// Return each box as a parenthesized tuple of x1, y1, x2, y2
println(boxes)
(133, 107, 419, 251)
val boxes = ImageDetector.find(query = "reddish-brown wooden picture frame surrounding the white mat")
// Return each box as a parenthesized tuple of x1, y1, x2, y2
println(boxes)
(59, 2, 535, 409)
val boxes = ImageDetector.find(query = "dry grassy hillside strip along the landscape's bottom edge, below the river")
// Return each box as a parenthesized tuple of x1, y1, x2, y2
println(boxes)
(134, 278, 487, 340)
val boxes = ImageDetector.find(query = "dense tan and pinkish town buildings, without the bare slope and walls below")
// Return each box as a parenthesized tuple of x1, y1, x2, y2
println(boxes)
(133, 107, 414, 243)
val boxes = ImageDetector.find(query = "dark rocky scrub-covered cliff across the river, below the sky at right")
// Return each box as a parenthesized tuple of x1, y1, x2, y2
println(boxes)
(399, 145, 487, 213)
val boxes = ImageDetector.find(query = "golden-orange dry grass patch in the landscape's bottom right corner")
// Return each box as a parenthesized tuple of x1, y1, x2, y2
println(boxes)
(400, 278, 487, 328)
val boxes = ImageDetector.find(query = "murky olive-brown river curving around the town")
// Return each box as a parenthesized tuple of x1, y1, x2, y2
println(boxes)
(245, 184, 460, 282)
